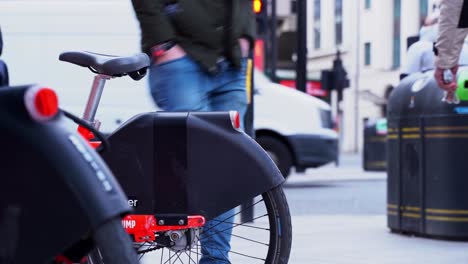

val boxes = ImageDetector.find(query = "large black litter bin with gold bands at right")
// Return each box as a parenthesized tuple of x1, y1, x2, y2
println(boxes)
(387, 68, 468, 240)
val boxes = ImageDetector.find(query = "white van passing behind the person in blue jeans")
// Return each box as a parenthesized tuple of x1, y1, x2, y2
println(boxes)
(0, 0, 338, 175)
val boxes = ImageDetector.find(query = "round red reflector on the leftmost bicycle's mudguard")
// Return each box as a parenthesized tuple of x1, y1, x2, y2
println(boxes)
(24, 86, 59, 121)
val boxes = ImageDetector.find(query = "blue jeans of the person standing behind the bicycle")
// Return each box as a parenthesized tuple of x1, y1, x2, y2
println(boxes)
(149, 56, 247, 264)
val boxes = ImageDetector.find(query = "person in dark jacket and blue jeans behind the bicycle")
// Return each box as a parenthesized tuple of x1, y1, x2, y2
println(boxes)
(132, 0, 255, 264)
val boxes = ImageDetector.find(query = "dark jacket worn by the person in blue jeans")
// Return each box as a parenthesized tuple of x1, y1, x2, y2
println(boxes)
(132, 0, 255, 72)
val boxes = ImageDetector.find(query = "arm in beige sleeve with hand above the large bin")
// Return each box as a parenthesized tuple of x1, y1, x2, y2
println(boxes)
(434, 0, 468, 91)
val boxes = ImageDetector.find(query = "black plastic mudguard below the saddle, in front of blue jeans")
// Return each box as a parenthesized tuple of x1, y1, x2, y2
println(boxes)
(103, 112, 284, 219)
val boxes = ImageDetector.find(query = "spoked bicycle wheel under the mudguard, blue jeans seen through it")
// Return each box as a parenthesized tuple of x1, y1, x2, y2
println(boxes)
(135, 186, 292, 264)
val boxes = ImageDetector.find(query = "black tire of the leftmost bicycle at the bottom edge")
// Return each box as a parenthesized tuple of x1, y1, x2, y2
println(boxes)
(86, 218, 139, 264)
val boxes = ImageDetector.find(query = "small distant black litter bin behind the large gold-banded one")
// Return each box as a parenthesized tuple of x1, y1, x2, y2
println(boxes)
(362, 118, 387, 171)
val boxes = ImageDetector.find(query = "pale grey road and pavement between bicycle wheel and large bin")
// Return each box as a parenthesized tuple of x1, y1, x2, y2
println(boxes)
(285, 154, 468, 264)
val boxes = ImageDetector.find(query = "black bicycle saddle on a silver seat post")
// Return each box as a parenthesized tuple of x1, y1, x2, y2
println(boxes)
(59, 51, 150, 80)
